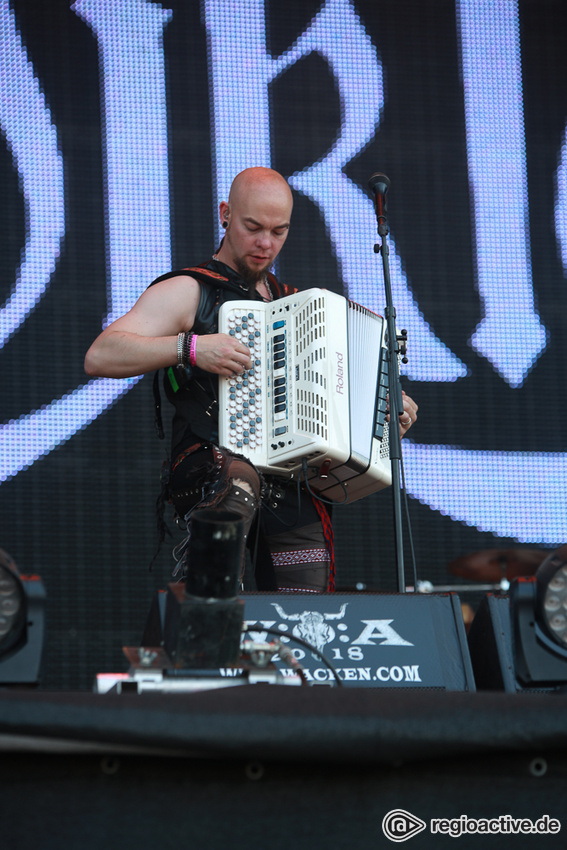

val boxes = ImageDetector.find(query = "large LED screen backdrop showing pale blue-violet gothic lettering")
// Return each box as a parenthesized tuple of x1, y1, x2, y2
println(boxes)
(0, 0, 567, 688)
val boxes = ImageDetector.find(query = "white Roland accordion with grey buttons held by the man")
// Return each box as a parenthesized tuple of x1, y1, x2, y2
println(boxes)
(219, 289, 391, 502)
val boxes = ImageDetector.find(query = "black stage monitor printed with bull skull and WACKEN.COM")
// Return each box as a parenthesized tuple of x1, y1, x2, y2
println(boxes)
(142, 591, 476, 691)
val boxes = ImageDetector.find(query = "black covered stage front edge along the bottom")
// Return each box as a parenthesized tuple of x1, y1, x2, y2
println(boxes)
(0, 685, 567, 850)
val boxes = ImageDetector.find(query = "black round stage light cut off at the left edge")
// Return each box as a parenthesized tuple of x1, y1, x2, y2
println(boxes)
(0, 549, 45, 685)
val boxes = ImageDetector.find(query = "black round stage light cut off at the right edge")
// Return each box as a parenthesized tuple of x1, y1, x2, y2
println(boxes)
(510, 545, 567, 690)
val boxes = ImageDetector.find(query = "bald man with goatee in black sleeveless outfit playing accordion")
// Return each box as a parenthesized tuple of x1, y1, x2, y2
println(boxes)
(85, 168, 417, 592)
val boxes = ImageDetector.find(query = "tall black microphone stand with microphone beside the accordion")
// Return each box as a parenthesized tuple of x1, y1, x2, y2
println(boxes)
(368, 174, 406, 593)
